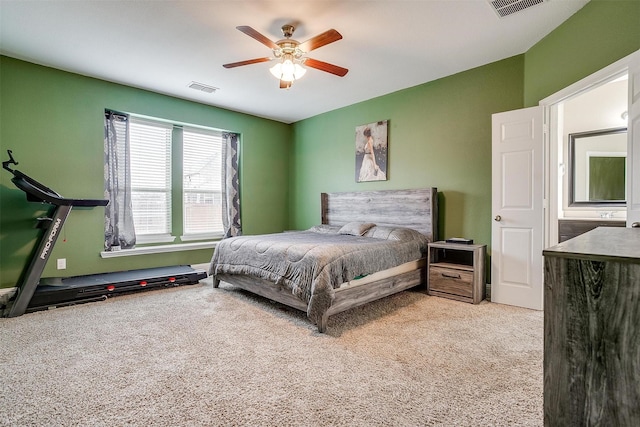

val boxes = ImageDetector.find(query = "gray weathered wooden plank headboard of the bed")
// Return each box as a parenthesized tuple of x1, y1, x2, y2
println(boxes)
(320, 187, 438, 242)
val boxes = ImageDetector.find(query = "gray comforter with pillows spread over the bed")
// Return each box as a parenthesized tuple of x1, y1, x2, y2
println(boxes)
(209, 223, 428, 319)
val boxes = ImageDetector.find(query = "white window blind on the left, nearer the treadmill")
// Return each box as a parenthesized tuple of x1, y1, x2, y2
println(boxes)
(129, 117, 173, 236)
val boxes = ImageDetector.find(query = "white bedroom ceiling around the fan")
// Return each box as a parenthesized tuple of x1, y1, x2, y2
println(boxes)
(0, 0, 588, 123)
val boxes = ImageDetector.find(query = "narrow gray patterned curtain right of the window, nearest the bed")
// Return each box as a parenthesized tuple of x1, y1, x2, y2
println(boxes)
(222, 132, 242, 238)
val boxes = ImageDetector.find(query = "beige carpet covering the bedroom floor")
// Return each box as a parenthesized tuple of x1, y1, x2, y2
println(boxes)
(0, 279, 543, 426)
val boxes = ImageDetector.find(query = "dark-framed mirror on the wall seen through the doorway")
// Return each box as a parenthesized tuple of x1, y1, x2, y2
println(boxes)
(569, 128, 627, 206)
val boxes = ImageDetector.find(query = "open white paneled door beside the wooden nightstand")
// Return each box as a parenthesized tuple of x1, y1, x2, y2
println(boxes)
(491, 107, 544, 310)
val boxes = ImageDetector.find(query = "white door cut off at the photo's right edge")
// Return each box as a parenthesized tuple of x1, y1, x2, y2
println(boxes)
(627, 54, 640, 227)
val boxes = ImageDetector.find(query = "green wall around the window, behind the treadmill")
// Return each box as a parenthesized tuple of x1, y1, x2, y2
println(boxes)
(0, 57, 291, 287)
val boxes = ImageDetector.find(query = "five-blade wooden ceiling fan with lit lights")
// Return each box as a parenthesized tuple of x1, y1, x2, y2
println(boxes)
(223, 24, 349, 89)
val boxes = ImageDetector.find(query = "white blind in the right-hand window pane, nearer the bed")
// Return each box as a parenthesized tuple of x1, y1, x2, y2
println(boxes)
(182, 128, 224, 237)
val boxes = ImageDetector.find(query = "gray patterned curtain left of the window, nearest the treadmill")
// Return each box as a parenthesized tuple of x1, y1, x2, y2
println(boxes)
(104, 111, 136, 251)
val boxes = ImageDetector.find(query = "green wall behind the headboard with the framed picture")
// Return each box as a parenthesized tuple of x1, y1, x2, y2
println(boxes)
(290, 55, 524, 243)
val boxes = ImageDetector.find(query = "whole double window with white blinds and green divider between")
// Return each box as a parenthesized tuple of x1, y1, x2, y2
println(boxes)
(129, 116, 224, 244)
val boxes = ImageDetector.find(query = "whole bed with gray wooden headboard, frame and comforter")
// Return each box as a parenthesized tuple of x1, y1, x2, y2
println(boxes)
(209, 187, 438, 332)
